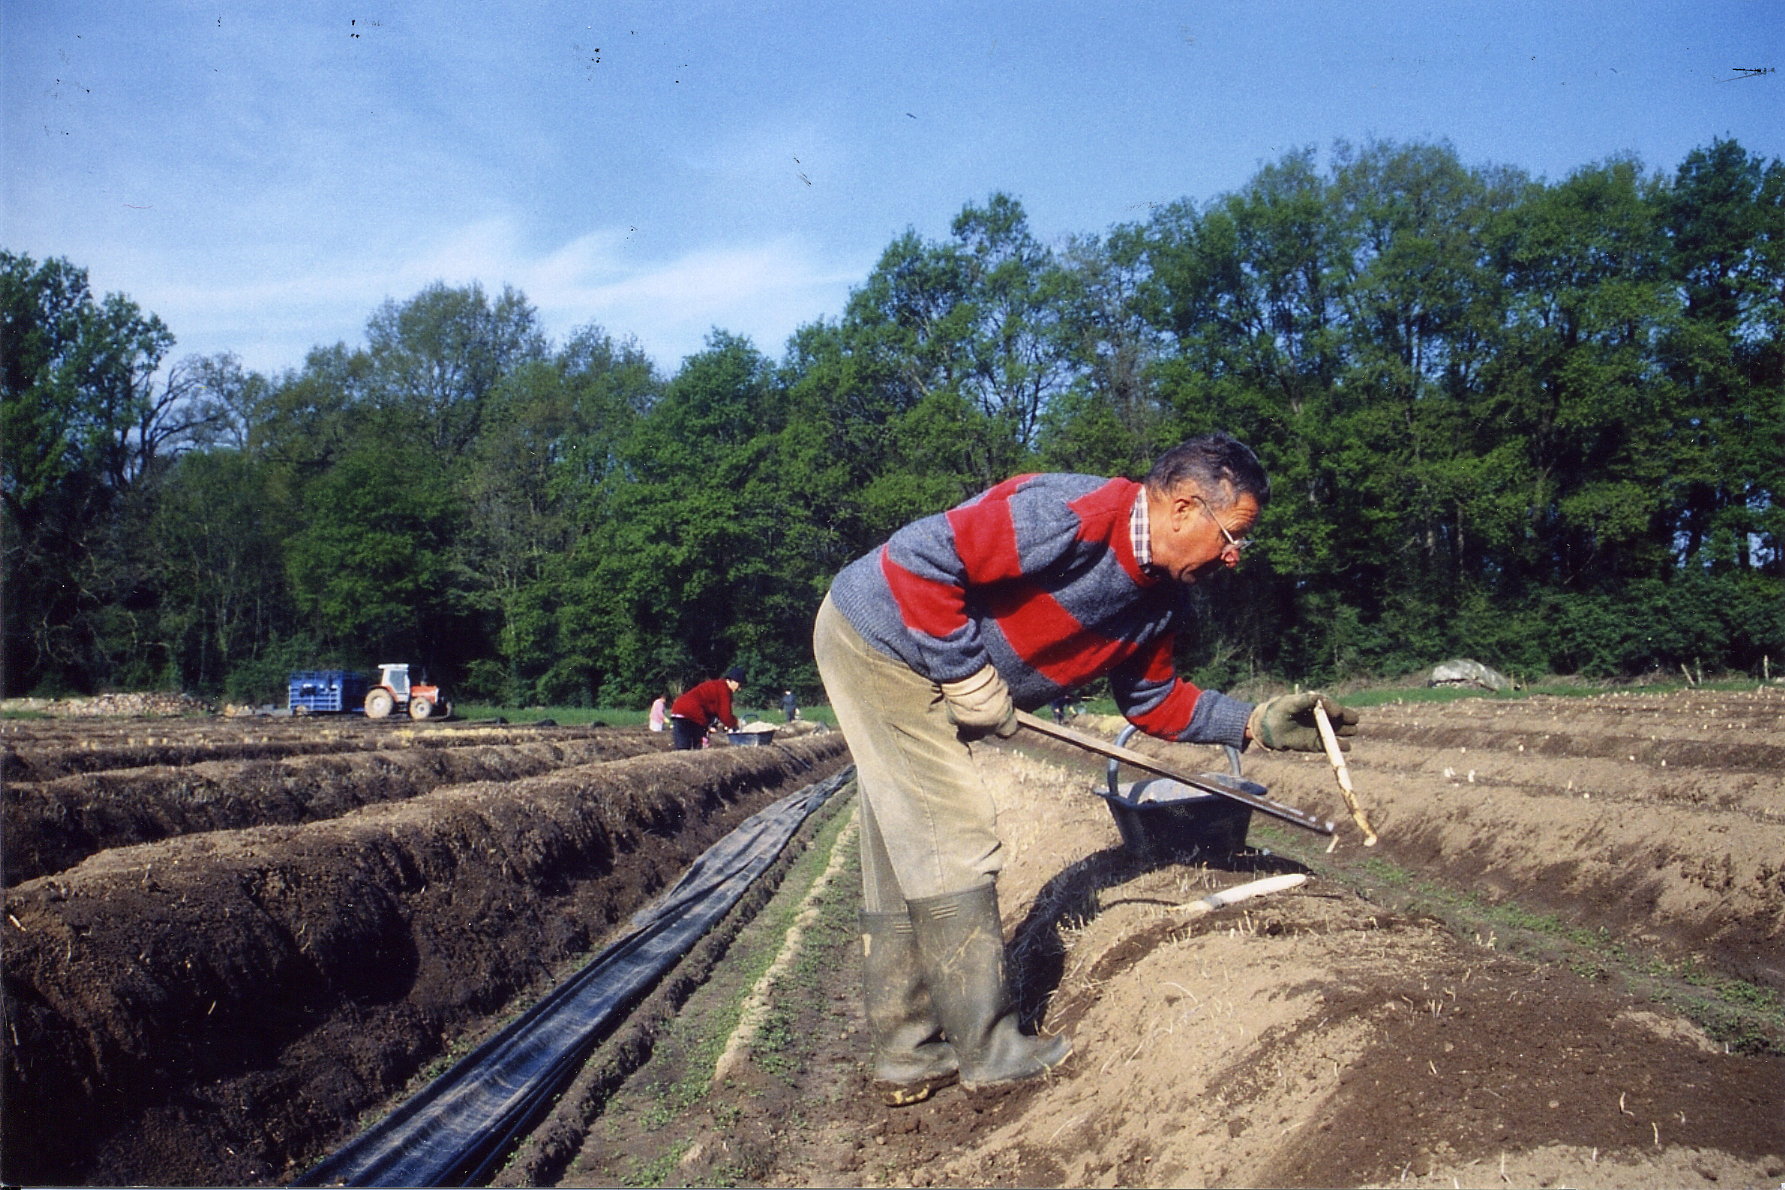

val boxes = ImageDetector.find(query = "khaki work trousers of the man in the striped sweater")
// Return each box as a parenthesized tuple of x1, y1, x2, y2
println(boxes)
(812, 596, 1003, 913)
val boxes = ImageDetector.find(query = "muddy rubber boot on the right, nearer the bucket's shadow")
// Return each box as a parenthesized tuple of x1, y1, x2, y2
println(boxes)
(910, 885, 1073, 1090)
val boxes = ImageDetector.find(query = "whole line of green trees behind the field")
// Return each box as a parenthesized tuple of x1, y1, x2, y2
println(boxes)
(0, 141, 1785, 705)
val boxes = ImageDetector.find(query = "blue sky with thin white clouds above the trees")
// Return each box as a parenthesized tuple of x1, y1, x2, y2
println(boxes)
(0, 0, 1785, 373)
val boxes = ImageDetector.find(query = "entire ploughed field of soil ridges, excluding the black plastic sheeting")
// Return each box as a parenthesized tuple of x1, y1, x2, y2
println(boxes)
(0, 687, 1785, 1186)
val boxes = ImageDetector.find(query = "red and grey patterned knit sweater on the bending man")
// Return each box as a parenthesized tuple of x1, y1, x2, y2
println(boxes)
(830, 475, 1251, 746)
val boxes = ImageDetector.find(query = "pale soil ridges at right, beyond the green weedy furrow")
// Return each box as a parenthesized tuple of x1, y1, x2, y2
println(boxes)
(1255, 687, 1785, 992)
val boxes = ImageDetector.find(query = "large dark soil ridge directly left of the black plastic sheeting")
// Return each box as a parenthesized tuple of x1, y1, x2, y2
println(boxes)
(4, 724, 846, 1185)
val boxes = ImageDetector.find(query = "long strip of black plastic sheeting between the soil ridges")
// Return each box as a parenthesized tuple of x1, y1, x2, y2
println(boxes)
(291, 769, 855, 1186)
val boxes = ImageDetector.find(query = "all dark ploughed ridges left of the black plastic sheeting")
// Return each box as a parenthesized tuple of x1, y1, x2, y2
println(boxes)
(0, 719, 846, 1185)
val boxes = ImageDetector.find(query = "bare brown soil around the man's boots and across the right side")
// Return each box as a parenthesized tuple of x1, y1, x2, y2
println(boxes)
(546, 690, 1785, 1186)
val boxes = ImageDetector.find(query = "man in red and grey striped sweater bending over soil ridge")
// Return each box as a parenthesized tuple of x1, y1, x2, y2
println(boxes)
(812, 434, 1357, 1106)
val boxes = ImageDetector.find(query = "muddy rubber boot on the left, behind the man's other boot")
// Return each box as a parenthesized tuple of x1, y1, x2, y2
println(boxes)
(862, 912, 960, 1108)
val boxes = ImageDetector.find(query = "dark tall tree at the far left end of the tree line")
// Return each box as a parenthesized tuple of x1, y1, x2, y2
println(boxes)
(0, 252, 223, 692)
